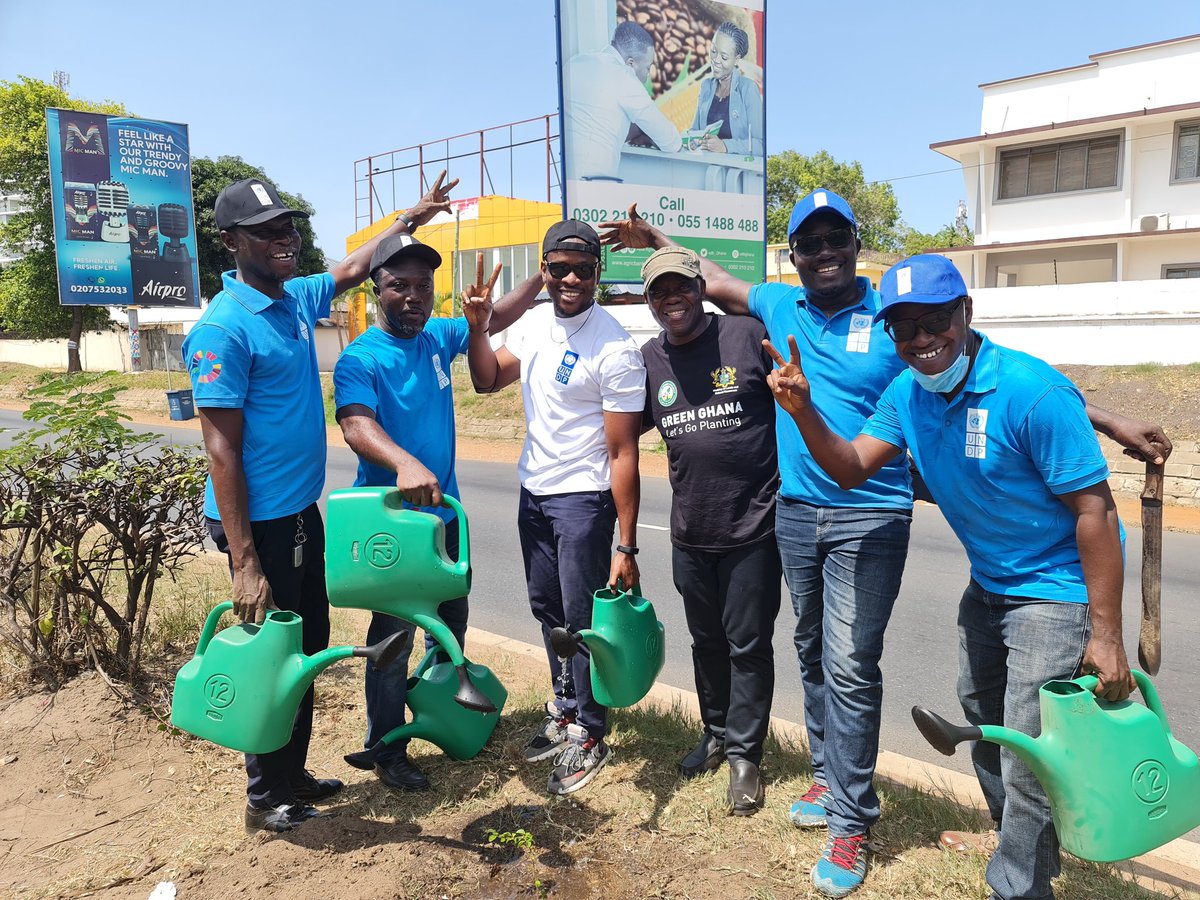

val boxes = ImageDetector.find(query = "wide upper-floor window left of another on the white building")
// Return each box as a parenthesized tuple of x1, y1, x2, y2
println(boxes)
(997, 134, 1121, 200)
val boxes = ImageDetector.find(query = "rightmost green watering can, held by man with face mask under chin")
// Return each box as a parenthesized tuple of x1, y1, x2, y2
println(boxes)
(912, 670, 1200, 863)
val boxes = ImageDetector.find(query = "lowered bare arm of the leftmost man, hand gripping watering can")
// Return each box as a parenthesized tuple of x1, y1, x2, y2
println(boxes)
(199, 407, 275, 625)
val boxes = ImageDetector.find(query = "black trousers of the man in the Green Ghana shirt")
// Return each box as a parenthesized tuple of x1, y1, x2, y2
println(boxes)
(671, 535, 782, 766)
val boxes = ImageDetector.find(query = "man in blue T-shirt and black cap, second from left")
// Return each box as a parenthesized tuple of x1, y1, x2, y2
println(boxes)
(334, 233, 524, 791)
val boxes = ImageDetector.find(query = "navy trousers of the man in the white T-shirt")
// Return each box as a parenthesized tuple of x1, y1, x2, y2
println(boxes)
(517, 487, 617, 739)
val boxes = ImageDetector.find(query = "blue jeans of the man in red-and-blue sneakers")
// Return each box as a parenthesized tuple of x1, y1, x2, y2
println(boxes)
(775, 497, 912, 835)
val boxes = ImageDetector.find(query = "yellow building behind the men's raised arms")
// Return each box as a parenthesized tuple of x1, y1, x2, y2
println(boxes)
(346, 196, 563, 303)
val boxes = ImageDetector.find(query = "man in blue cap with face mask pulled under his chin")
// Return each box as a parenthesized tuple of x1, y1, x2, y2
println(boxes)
(768, 256, 1134, 900)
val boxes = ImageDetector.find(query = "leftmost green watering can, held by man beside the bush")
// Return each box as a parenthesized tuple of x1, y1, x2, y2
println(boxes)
(170, 600, 408, 754)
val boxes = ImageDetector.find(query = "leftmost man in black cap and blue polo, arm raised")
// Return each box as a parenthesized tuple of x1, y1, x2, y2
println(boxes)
(184, 173, 457, 832)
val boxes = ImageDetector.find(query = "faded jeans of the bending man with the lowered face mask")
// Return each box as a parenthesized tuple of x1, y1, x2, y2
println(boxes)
(959, 580, 1091, 900)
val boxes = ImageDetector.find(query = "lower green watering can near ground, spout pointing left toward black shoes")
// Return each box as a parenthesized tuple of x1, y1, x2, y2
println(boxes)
(346, 650, 509, 769)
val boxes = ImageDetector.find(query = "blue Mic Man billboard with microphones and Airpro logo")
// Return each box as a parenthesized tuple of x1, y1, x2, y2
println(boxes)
(46, 109, 200, 307)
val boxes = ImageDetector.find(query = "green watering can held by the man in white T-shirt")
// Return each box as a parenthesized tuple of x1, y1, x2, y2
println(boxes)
(550, 583, 666, 707)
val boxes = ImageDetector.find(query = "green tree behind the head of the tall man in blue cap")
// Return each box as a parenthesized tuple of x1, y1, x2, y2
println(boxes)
(767, 150, 900, 252)
